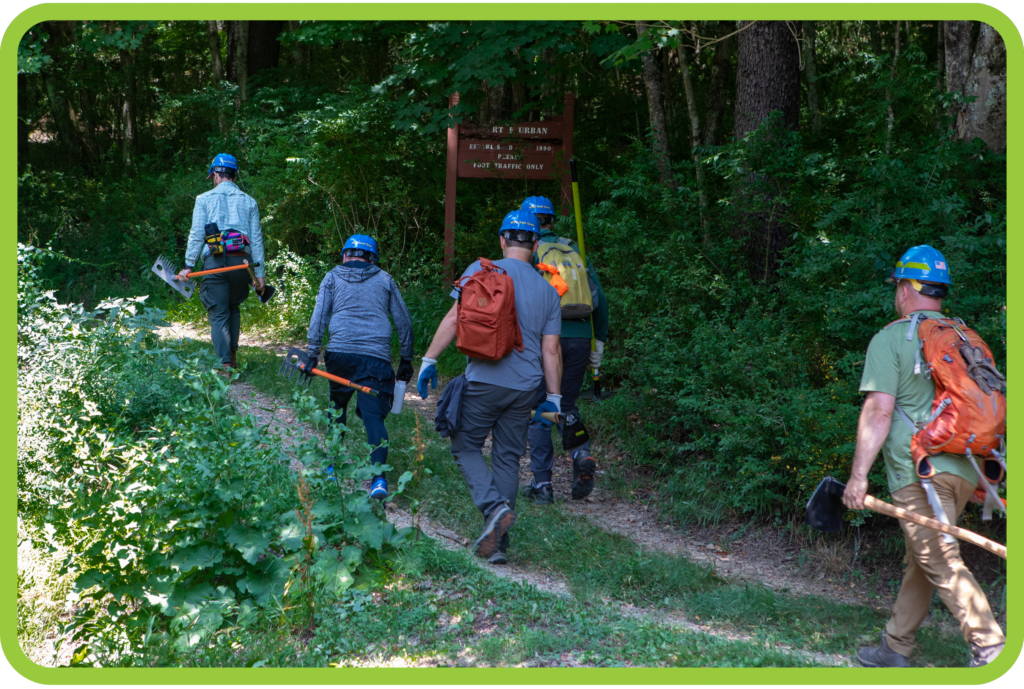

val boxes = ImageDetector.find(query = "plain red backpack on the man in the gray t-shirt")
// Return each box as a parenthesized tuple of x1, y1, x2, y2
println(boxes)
(454, 258, 522, 361)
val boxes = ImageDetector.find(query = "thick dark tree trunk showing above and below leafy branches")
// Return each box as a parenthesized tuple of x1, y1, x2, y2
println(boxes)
(733, 21, 800, 283)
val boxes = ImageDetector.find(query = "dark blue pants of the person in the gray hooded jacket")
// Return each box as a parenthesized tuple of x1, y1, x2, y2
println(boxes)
(324, 351, 394, 476)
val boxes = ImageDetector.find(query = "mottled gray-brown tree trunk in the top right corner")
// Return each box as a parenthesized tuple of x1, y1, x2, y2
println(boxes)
(944, 21, 1007, 153)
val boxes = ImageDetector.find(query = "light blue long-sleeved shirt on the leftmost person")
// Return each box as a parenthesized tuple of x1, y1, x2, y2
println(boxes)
(185, 181, 264, 277)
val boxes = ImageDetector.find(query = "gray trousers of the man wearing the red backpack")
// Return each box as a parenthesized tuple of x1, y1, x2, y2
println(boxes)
(452, 383, 535, 516)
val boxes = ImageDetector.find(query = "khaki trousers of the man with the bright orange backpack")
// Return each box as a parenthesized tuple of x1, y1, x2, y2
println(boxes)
(886, 473, 1006, 655)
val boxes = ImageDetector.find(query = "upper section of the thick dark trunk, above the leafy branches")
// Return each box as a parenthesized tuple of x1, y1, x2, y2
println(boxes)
(735, 21, 800, 140)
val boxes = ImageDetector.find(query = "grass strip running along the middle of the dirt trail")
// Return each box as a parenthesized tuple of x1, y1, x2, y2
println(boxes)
(163, 343, 968, 665)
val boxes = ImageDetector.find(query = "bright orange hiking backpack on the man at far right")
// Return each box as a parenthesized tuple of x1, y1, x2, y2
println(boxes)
(896, 313, 1007, 485)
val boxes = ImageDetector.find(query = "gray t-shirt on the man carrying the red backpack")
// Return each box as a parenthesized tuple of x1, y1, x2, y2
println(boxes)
(452, 258, 562, 391)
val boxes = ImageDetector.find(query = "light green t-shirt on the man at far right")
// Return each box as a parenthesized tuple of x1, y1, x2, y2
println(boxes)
(860, 311, 978, 492)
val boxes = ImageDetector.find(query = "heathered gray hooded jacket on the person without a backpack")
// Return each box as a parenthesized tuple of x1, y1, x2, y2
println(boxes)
(307, 261, 413, 361)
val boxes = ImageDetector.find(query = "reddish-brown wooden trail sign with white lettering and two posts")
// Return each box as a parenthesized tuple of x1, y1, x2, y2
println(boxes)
(444, 91, 575, 283)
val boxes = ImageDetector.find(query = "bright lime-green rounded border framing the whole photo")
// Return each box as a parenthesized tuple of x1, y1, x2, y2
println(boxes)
(0, 2, 1024, 686)
